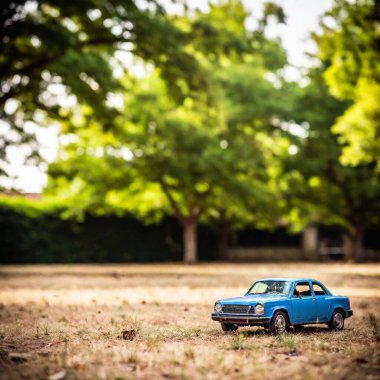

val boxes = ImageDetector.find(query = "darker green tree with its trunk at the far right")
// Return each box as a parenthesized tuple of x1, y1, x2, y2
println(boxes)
(283, 66, 380, 261)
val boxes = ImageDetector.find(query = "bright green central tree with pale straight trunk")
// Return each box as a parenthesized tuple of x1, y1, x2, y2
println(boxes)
(50, 1, 286, 262)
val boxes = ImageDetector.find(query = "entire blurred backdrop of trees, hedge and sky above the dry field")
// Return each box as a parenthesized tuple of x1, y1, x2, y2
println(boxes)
(0, 0, 380, 263)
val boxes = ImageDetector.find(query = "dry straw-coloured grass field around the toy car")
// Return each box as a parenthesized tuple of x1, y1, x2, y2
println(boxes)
(0, 263, 380, 380)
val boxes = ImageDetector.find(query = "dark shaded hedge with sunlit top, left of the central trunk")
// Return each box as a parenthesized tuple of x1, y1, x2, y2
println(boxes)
(0, 197, 216, 263)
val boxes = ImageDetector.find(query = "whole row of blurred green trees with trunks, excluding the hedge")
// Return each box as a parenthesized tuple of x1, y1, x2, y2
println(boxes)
(0, 0, 380, 262)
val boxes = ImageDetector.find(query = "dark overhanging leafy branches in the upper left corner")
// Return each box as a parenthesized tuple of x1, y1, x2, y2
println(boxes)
(0, 0, 207, 181)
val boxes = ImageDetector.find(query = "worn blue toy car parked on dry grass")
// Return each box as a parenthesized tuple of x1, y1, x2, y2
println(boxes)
(211, 278, 353, 334)
